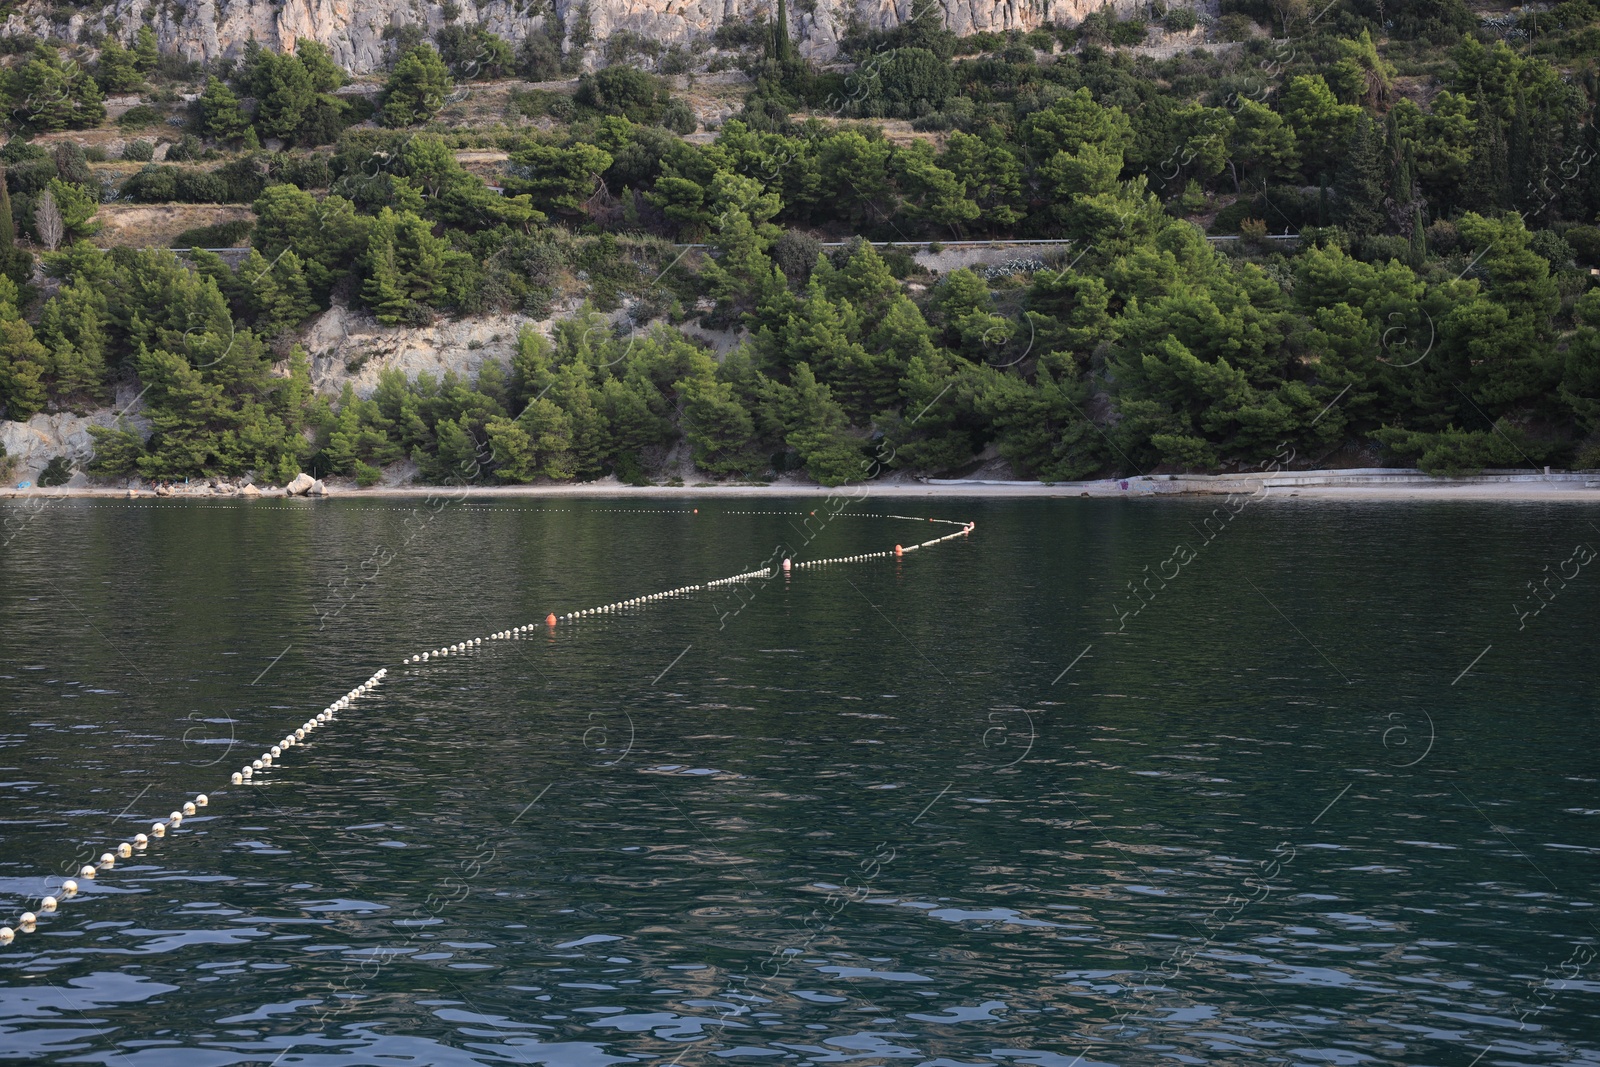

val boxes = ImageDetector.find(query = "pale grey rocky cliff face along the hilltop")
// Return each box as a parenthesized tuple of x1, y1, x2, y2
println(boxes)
(3, 0, 1134, 74)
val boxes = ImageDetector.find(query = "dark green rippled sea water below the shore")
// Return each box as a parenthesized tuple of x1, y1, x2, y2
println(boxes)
(0, 499, 1600, 1067)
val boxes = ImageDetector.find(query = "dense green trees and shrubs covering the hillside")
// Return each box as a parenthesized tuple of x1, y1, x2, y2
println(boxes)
(0, 0, 1600, 483)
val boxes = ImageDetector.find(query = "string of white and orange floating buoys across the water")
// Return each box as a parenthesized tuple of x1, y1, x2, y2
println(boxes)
(0, 509, 978, 945)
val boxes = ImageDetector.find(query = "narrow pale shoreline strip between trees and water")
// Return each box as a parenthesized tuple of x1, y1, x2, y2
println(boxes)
(9, 469, 1600, 504)
